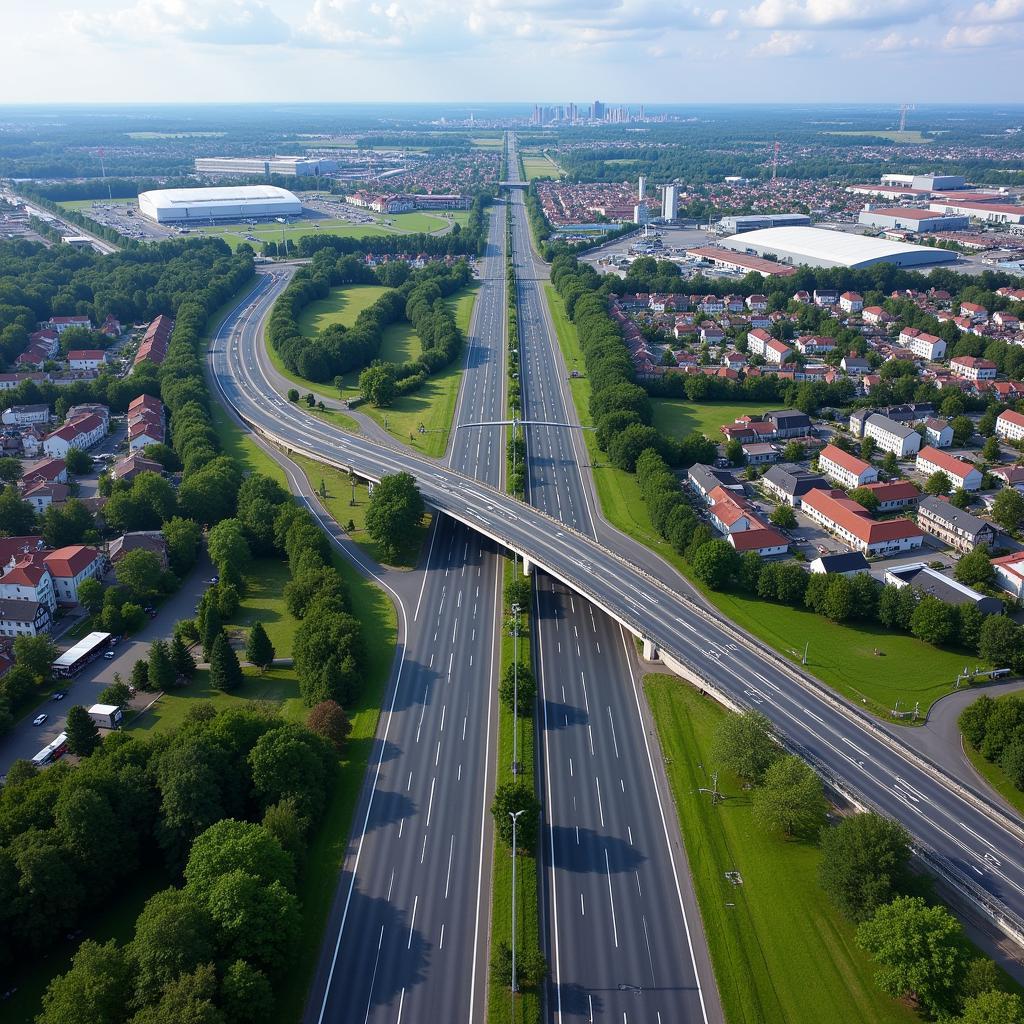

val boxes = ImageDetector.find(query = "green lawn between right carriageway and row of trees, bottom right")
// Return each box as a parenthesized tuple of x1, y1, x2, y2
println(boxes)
(644, 675, 920, 1024)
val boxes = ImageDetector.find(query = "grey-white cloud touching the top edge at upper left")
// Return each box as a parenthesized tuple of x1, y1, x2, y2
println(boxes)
(67, 0, 292, 46)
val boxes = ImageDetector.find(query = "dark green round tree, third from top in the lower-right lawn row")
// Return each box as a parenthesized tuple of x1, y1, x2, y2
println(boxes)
(818, 814, 910, 924)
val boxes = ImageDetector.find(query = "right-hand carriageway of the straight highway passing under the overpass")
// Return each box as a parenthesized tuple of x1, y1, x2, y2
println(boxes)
(509, 136, 722, 1024)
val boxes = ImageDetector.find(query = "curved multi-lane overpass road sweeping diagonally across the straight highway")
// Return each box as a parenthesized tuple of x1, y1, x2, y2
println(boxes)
(213, 193, 1024, 1007)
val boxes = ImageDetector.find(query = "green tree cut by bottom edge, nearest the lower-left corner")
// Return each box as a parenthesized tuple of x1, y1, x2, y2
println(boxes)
(36, 939, 132, 1024)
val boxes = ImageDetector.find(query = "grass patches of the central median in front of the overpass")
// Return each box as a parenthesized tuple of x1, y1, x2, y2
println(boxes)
(487, 559, 541, 1024)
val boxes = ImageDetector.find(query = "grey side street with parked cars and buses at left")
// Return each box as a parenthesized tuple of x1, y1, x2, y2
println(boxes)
(0, 548, 213, 775)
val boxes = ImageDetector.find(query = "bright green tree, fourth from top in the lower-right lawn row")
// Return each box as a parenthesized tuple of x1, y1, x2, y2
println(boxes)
(857, 896, 968, 1016)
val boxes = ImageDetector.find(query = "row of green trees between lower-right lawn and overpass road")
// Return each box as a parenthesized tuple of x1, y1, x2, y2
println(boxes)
(712, 711, 1024, 1024)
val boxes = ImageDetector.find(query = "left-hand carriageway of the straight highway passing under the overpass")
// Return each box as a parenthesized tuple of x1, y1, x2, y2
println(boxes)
(282, 201, 505, 1024)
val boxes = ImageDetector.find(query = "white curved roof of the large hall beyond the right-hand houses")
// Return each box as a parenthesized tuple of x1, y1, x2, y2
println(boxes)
(721, 227, 955, 269)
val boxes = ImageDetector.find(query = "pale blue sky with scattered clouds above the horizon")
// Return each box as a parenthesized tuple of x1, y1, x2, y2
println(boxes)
(0, 0, 1024, 105)
